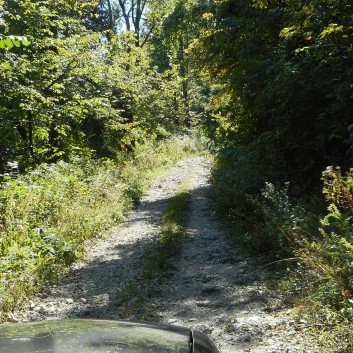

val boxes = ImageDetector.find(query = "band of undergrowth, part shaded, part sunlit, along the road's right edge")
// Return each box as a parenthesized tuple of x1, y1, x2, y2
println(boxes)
(213, 151, 353, 353)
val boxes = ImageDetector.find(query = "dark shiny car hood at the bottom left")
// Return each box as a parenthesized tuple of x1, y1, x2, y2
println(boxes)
(0, 320, 218, 353)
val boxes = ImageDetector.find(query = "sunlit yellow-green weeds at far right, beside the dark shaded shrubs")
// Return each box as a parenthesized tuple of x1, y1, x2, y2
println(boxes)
(299, 167, 353, 312)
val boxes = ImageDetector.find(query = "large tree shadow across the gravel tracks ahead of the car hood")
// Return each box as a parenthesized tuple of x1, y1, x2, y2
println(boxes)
(51, 185, 262, 330)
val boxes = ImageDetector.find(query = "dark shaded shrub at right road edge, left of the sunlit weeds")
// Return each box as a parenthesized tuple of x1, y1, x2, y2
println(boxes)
(212, 142, 305, 259)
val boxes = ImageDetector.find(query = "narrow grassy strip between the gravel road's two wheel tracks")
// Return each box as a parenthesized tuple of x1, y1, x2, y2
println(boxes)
(144, 183, 191, 279)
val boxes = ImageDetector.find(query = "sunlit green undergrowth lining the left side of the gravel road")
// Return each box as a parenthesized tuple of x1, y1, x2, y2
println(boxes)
(0, 138, 198, 321)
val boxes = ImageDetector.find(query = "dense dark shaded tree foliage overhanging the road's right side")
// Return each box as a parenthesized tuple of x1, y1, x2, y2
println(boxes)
(190, 0, 353, 193)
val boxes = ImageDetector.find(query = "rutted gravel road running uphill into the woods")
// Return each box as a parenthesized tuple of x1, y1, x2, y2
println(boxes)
(13, 157, 316, 353)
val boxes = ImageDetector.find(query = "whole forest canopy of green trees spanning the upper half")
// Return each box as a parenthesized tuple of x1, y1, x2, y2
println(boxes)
(0, 0, 353, 182)
